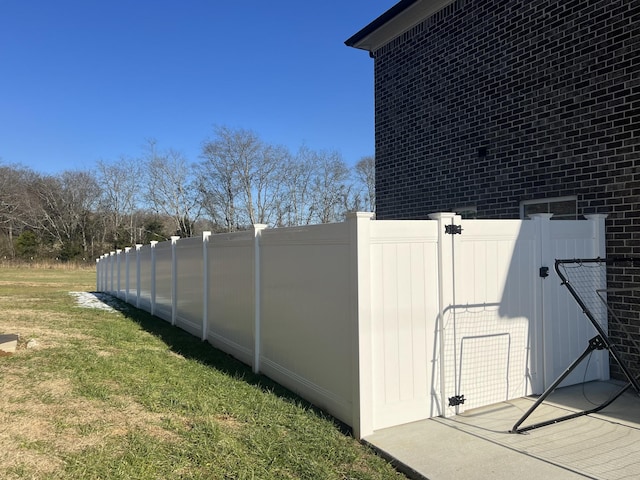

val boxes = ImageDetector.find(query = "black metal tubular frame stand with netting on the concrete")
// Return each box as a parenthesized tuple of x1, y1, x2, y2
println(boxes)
(509, 259, 640, 433)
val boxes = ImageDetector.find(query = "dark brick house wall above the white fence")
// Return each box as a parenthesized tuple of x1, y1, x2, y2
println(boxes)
(373, 0, 640, 380)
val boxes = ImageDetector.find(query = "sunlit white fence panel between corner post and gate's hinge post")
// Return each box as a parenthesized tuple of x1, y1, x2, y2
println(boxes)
(370, 221, 439, 429)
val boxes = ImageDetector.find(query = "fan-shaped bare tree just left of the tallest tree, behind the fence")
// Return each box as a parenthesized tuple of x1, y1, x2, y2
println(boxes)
(145, 140, 202, 237)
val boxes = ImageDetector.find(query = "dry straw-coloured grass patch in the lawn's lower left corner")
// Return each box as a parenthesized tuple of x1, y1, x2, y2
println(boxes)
(0, 369, 184, 477)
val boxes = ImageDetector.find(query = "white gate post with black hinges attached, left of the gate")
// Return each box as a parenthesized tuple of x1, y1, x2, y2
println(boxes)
(429, 212, 461, 416)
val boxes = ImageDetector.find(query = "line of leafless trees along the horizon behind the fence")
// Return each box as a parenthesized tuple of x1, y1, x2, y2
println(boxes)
(0, 126, 375, 262)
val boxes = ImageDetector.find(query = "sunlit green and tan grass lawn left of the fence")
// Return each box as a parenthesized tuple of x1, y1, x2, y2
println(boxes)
(0, 268, 404, 480)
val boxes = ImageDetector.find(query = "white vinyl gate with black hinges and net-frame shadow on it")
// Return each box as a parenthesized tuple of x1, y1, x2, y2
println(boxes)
(442, 220, 540, 413)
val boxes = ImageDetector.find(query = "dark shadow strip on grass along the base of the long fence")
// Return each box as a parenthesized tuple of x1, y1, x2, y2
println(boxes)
(96, 292, 353, 436)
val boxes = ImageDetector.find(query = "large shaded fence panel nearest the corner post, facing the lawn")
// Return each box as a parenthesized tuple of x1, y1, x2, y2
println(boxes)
(260, 223, 354, 422)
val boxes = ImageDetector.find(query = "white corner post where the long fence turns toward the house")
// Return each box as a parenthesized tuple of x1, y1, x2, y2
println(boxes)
(347, 212, 374, 438)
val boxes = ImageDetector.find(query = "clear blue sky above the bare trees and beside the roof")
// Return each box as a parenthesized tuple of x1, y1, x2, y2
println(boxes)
(0, 0, 396, 173)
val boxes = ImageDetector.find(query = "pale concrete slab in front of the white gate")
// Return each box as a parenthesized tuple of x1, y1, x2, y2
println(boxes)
(364, 382, 640, 480)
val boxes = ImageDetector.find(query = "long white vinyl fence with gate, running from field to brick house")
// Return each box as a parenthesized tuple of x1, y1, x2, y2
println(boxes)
(97, 213, 609, 438)
